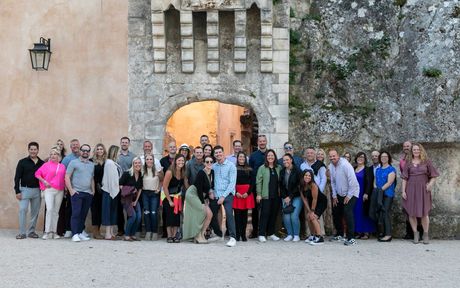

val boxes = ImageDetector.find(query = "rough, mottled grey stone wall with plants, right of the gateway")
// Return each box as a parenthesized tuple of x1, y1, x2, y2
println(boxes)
(290, 0, 460, 237)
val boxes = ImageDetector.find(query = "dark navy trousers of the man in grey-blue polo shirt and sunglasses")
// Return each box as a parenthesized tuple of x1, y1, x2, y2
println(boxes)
(70, 192, 93, 235)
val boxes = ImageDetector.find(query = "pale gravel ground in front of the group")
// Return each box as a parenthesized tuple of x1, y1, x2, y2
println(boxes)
(0, 230, 460, 288)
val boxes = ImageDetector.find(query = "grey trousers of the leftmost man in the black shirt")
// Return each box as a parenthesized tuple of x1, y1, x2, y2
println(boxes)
(19, 187, 41, 234)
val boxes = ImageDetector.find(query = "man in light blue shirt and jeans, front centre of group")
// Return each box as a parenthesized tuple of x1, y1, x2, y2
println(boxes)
(209, 145, 236, 247)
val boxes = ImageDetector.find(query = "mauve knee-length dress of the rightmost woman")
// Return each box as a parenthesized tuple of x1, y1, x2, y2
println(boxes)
(402, 160, 439, 217)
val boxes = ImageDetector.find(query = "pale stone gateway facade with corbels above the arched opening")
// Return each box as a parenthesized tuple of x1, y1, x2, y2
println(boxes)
(128, 0, 289, 154)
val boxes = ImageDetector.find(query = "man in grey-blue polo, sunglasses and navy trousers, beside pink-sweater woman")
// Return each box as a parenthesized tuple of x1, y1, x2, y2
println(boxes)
(65, 144, 95, 242)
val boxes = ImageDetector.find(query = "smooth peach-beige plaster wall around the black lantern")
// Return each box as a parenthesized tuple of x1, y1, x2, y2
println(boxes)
(0, 0, 128, 228)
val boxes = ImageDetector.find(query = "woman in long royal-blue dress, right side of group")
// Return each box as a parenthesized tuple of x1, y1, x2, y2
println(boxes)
(354, 152, 375, 239)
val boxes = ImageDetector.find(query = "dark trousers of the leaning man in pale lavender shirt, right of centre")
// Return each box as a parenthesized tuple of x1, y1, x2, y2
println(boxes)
(332, 195, 357, 240)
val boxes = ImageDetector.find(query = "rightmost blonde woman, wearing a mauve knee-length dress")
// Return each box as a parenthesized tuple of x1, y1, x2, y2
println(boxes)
(401, 143, 439, 244)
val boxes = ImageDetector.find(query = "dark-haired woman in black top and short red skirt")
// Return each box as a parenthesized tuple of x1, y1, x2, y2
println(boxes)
(233, 152, 255, 242)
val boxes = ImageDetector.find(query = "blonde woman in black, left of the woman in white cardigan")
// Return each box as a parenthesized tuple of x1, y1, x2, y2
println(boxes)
(91, 143, 107, 239)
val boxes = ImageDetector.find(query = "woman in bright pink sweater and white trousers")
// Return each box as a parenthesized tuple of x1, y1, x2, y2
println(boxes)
(35, 147, 65, 240)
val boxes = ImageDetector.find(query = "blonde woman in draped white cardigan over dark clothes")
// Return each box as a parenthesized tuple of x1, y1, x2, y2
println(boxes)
(101, 145, 123, 240)
